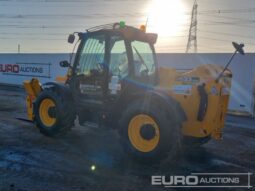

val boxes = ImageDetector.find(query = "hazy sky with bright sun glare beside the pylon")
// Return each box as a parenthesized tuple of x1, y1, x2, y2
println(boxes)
(0, 0, 255, 53)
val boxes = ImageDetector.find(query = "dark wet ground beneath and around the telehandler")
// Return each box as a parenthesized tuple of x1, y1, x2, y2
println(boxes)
(0, 87, 255, 191)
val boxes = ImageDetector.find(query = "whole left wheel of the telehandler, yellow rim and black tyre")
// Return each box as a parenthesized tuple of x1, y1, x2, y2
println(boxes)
(34, 88, 75, 136)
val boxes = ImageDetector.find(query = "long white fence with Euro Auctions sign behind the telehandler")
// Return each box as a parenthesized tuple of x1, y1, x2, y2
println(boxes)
(0, 53, 255, 114)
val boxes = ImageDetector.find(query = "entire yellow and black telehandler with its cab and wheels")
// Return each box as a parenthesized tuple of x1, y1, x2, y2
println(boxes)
(24, 22, 244, 160)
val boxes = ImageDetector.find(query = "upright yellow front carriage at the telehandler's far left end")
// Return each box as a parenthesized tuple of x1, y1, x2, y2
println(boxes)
(23, 78, 42, 121)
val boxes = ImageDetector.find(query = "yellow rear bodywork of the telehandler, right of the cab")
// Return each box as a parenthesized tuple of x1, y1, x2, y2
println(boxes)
(159, 65, 231, 139)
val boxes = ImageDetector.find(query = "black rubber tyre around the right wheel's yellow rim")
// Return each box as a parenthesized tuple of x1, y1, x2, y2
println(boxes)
(119, 100, 181, 163)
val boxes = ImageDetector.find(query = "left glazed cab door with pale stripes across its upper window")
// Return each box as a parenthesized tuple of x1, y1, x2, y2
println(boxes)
(76, 34, 107, 109)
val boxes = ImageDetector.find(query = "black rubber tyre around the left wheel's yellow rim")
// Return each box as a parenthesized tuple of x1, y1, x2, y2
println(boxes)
(34, 87, 76, 137)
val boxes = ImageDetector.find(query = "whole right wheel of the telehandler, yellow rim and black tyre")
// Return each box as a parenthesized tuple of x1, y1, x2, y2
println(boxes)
(120, 101, 180, 162)
